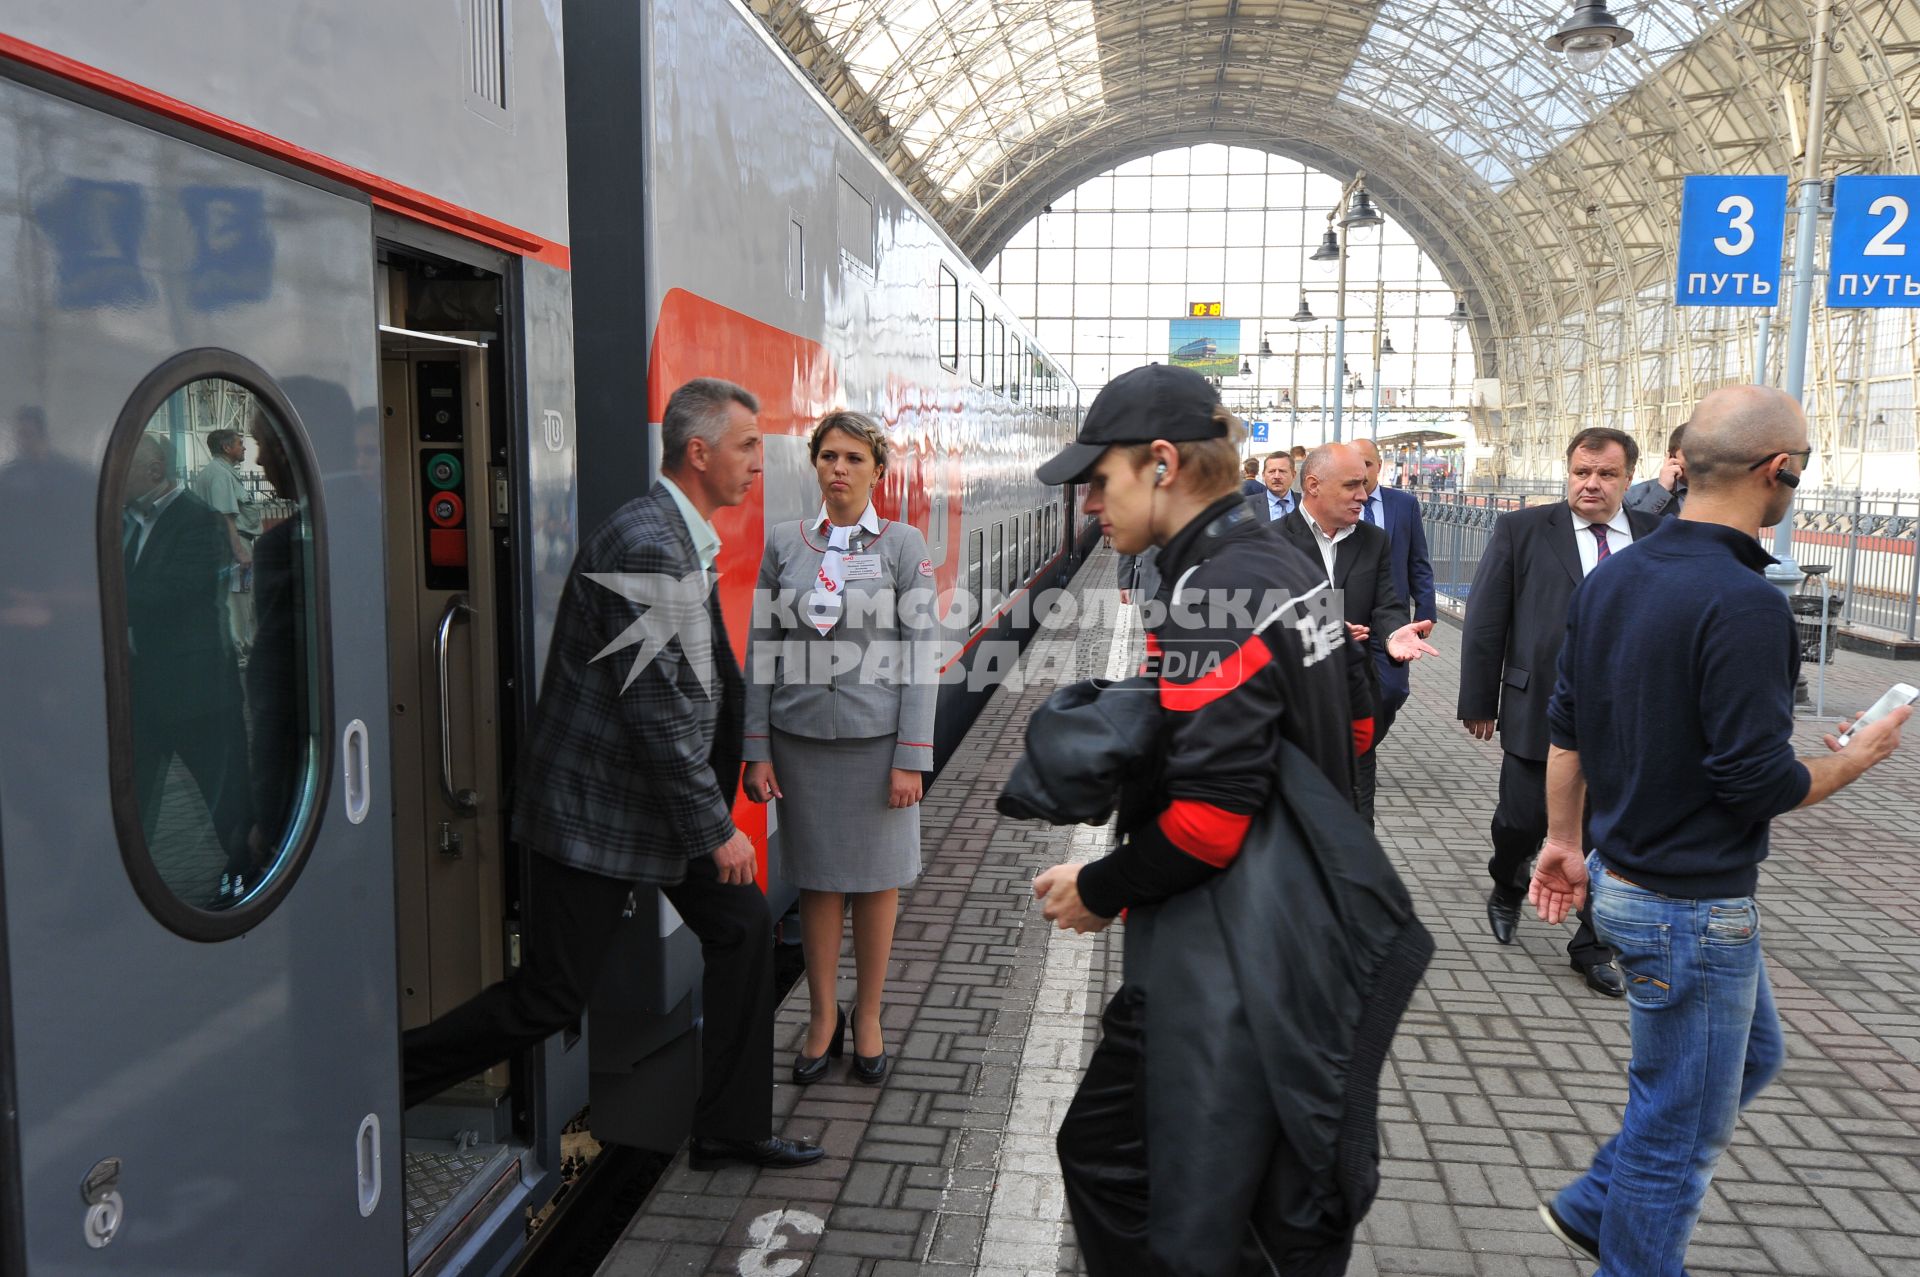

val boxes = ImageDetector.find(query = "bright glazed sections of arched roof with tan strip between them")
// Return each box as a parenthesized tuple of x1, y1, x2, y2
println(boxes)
(772, 0, 1732, 200)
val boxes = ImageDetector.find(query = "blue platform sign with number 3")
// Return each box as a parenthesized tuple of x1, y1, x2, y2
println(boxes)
(1674, 177, 1788, 305)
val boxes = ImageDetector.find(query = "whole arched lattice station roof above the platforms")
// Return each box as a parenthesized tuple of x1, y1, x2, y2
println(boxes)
(747, 0, 1920, 466)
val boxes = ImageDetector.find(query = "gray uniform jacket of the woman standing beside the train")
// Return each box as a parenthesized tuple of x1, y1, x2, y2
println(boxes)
(745, 518, 941, 772)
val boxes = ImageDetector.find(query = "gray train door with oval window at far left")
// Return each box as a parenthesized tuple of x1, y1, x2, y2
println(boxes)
(0, 79, 405, 1277)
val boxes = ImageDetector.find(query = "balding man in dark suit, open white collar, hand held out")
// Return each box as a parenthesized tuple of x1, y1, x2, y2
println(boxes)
(1275, 444, 1438, 824)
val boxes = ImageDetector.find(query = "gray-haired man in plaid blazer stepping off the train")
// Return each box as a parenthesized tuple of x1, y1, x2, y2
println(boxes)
(405, 378, 820, 1169)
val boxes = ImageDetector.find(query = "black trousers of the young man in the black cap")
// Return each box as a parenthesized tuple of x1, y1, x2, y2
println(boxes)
(1054, 985, 1273, 1277)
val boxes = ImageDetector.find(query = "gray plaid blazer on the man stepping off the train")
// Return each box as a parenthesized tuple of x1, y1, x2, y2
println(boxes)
(513, 484, 743, 883)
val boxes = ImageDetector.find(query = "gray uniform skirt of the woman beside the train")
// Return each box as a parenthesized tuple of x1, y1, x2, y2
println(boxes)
(770, 728, 920, 891)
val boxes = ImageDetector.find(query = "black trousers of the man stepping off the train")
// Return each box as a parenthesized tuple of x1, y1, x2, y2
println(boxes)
(405, 855, 774, 1139)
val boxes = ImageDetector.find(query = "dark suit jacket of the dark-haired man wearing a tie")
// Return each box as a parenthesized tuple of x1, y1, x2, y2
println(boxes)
(1459, 501, 1661, 762)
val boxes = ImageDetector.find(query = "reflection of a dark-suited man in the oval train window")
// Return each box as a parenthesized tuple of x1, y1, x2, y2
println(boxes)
(121, 434, 253, 908)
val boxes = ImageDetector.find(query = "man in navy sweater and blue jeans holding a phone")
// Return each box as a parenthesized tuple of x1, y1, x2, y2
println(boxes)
(1530, 386, 1908, 1277)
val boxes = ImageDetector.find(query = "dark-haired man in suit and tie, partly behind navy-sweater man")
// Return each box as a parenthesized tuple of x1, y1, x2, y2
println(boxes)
(1459, 426, 1659, 997)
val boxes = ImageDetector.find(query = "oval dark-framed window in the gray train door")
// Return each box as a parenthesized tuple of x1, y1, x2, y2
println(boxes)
(98, 349, 332, 941)
